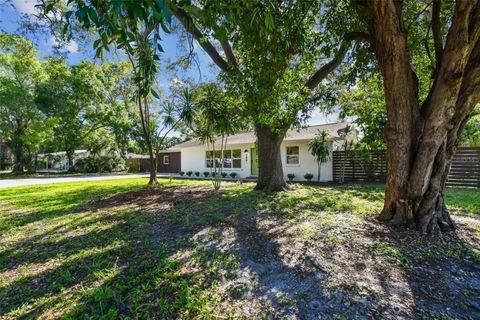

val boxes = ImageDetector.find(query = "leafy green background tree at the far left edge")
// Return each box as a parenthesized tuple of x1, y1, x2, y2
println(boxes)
(0, 33, 48, 174)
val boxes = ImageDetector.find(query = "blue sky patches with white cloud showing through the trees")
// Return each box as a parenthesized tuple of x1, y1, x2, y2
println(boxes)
(0, 0, 338, 125)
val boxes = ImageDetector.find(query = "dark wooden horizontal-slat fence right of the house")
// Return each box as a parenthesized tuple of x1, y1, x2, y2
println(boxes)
(333, 147, 480, 188)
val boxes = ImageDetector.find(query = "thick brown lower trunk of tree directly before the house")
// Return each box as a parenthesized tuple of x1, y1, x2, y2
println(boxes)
(255, 125, 288, 192)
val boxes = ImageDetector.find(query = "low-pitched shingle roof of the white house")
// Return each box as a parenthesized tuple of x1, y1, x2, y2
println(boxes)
(173, 122, 348, 149)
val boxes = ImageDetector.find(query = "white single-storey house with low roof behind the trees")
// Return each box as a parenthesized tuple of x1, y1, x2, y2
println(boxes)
(169, 123, 356, 181)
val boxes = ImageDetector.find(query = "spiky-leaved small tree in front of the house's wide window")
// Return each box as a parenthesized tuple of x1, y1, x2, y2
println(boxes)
(194, 84, 239, 191)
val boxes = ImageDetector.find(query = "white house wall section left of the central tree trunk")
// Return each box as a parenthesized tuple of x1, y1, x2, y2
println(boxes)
(181, 144, 254, 178)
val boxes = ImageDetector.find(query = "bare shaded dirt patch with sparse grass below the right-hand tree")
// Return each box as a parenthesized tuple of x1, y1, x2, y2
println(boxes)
(7, 186, 480, 319)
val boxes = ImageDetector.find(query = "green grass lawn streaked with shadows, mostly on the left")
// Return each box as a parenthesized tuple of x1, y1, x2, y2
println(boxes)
(0, 179, 480, 319)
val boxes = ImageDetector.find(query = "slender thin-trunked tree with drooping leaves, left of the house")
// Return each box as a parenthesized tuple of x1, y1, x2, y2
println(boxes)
(41, 0, 171, 185)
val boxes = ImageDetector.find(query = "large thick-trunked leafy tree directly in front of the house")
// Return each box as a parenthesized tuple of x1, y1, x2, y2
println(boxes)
(167, 0, 362, 191)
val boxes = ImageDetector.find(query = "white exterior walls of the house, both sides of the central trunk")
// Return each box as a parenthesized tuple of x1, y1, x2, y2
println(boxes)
(181, 141, 333, 181)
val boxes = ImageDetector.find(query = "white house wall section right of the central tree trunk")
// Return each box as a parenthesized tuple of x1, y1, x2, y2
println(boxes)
(281, 141, 333, 181)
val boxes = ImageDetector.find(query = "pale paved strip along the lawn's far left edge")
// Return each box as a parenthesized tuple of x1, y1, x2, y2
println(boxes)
(0, 173, 148, 188)
